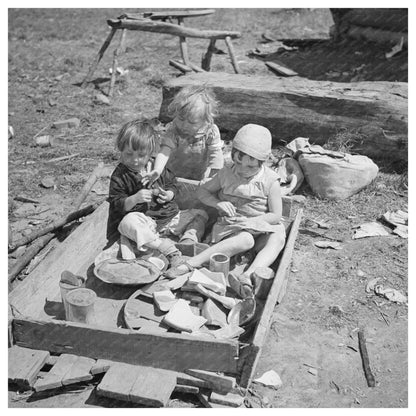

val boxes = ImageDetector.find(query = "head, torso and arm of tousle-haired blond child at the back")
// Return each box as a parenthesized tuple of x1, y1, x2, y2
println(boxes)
(144, 87, 224, 183)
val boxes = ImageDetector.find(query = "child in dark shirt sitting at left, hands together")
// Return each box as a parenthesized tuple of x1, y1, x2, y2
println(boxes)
(108, 120, 208, 266)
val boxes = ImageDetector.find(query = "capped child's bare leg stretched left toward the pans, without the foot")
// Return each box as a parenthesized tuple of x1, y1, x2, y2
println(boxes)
(184, 231, 254, 268)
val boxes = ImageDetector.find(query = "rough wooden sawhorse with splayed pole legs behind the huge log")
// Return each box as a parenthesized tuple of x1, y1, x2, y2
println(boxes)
(81, 9, 241, 97)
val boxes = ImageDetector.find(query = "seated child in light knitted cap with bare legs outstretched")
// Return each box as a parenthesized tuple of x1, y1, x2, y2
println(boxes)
(168, 124, 286, 296)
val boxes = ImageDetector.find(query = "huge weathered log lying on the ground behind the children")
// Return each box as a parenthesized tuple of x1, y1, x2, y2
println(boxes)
(159, 72, 408, 161)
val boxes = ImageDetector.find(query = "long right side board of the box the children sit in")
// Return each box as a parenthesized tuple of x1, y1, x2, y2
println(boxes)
(240, 208, 303, 387)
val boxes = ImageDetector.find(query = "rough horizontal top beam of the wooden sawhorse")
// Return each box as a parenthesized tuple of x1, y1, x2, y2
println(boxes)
(107, 19, 241, 39)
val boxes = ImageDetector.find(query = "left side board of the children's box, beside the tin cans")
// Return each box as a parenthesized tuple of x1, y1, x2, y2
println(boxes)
(9, 202, 109, 318)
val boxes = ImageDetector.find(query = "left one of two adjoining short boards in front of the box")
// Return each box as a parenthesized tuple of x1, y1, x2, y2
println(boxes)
(96, 363, 140, 401)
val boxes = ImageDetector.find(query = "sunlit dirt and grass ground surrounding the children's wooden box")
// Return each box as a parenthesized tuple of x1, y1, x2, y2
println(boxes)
(8, 9, 408, 408)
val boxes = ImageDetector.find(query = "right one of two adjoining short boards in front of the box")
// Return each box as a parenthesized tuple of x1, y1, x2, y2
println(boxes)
(130, 367, 176, 407)
